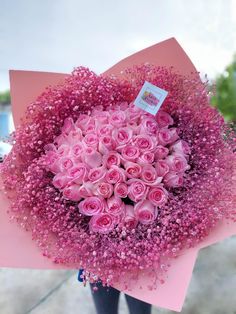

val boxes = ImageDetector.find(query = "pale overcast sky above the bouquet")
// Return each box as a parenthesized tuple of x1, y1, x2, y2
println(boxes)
(0, 0, 236, 90)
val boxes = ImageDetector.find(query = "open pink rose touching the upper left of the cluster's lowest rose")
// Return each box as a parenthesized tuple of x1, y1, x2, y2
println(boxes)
(78, 196, 105, 216)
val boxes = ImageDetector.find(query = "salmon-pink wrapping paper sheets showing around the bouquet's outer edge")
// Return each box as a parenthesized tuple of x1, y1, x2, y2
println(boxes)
(0, 38, 236, 312)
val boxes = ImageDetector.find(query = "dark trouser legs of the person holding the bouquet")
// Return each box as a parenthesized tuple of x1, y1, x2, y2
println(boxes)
(90, 283, 152, 314)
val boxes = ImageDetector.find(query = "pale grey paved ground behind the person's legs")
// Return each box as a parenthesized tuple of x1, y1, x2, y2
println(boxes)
(0, 237, 236, 314)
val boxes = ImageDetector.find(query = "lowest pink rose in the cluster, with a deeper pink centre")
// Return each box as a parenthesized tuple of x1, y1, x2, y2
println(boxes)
(89, 213, 115, 234)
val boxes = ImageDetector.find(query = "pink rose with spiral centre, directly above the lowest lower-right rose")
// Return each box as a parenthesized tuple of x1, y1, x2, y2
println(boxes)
(127, 179, 148, 202)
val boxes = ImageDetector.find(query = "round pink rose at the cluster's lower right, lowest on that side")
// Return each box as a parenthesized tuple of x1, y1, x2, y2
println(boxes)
(134, 200, 157, 225)
